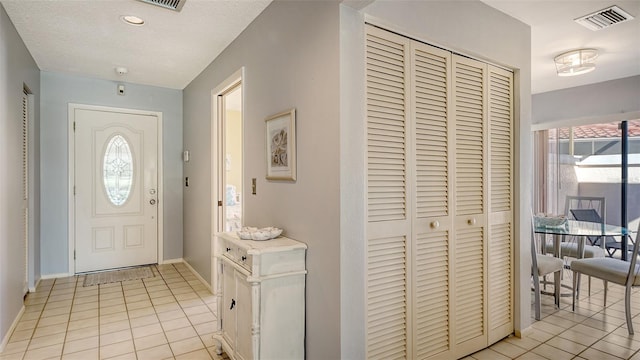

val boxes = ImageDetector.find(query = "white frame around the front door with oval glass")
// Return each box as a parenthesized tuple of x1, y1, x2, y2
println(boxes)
(67, 103, 164, 275)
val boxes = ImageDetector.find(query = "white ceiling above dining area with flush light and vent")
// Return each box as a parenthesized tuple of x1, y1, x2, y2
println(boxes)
(482, 0, 640, 94)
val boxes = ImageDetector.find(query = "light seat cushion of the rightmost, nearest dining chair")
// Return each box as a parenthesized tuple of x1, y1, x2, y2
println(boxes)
(571, 258, 640, 286)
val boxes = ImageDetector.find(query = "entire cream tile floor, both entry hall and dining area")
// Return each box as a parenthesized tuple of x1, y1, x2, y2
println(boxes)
(5, 264, 640, 360)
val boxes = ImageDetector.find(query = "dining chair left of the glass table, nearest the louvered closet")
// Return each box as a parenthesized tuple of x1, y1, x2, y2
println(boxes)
(531, 224, 564, 320)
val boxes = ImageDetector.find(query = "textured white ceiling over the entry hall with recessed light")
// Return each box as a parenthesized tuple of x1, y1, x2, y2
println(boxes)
(1, 0, 271, 89)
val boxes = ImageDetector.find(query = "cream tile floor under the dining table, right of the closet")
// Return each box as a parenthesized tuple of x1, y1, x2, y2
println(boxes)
(467, 271, 640, 360)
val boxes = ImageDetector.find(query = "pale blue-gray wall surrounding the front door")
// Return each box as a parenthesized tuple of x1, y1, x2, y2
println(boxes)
(40, 72, 182, 275)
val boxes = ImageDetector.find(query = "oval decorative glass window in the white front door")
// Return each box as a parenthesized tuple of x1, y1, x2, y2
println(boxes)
(102, 134, 134, 206)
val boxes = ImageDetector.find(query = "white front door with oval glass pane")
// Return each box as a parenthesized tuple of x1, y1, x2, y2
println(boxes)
(74, 109, 158, 273)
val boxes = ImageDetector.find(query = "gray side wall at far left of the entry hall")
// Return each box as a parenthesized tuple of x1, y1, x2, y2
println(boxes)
(0, 2, 40, 350)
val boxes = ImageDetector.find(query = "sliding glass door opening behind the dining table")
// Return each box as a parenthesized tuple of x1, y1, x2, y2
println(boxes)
(534, 120, 640, 260)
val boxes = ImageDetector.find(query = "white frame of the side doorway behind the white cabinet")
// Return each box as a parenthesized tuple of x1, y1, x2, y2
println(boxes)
(210, 66, 246, 294)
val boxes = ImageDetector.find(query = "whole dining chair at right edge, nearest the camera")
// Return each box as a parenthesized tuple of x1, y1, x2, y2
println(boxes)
(571, 224, 640, 335)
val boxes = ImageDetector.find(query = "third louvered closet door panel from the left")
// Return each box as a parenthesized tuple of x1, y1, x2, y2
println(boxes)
(452, 55, 487, 356)
